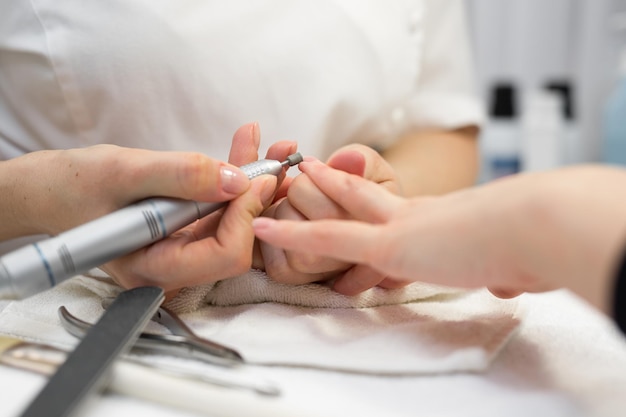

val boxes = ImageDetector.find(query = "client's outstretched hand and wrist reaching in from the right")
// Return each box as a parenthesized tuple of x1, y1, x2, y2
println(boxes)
(254, 160, 626, 312)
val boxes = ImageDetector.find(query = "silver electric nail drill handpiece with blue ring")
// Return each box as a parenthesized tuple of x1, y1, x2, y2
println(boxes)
(0, 154, 302, 298)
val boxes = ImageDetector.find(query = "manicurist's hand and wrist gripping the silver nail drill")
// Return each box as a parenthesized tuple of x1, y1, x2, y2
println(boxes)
(0, 124, 295, 291)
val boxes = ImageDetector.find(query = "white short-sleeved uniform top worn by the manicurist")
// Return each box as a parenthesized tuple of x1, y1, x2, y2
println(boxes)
(0, 0, 483, 159)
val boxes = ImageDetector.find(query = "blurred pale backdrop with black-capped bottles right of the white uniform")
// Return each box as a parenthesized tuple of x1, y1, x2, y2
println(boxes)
(466, 0, 626, 181)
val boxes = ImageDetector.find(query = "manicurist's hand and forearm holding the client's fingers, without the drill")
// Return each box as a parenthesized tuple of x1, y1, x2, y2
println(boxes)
(254, 127, 478, 295)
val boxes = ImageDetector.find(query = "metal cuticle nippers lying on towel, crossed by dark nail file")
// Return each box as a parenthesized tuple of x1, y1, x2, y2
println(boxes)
(59, 299, 244, 366)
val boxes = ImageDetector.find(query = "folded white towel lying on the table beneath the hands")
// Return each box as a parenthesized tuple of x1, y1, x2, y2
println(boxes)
(0, 270, 520, 375)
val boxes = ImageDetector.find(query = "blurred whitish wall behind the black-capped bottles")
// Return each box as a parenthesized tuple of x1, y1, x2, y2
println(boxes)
(466, 0, 626, 177)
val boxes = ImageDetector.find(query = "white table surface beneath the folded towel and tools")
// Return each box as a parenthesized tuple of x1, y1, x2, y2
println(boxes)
(0, 291, 626, 417)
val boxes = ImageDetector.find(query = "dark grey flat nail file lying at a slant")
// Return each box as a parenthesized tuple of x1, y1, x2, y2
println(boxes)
(22, 287, 164, 417)
